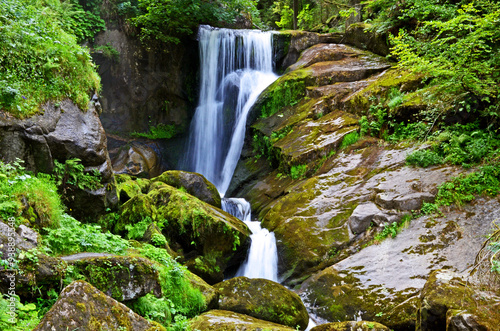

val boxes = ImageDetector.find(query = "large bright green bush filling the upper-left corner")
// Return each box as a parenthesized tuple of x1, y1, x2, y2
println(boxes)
(0, 0, 100, 117)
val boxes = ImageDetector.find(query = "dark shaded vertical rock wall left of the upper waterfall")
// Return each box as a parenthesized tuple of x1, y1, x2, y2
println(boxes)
(92, 23, 199, 135)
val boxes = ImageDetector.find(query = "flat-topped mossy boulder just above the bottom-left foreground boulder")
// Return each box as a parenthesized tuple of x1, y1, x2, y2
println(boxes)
(68, 256, 162, 301)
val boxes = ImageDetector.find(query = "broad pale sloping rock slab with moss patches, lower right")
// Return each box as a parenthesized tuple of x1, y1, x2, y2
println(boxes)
(301, 200, 500, 330)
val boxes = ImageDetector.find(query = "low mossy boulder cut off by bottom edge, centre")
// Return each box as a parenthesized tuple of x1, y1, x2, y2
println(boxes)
(189, 310, 295, 331)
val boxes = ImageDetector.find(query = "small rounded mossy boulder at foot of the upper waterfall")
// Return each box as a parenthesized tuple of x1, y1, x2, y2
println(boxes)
(153, 170, 221, 208)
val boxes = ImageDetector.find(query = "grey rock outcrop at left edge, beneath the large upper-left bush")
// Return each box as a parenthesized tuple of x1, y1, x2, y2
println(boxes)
(0, 100, 117, 218)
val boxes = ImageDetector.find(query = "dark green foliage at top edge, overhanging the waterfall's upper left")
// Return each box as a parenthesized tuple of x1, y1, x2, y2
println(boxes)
(131, 0, 256, 44)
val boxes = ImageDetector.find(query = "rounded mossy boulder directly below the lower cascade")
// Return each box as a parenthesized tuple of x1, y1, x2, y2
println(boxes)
(214, 277, 309, 330)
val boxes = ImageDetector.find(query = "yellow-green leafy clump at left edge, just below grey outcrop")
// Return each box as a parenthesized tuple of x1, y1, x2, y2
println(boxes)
(0, 160, 63, 227)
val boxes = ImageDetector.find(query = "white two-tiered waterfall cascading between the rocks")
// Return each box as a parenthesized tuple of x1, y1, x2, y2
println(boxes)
(185, 26, 278, 281)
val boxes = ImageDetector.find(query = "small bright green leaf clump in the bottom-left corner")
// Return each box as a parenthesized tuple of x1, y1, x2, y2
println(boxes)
(0, 294, 41, 331)
